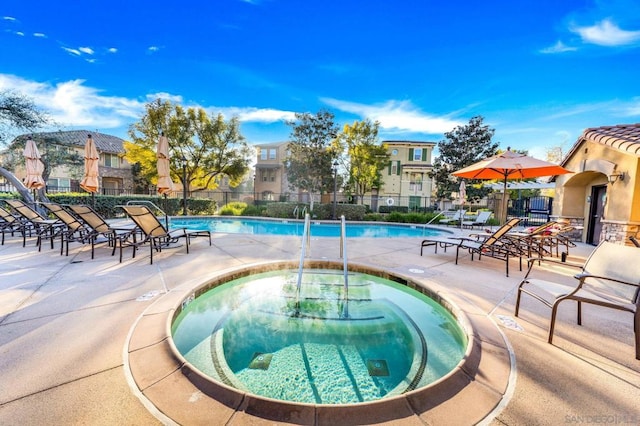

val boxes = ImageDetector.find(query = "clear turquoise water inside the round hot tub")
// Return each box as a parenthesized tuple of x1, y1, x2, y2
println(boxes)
(172, 270, 467, 404)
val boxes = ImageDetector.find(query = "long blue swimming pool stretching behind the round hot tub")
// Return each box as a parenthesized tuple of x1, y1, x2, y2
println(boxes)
(170, 217, 448, 238)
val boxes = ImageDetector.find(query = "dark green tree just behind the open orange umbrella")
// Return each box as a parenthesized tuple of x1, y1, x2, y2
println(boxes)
(429, 116, 499, 199)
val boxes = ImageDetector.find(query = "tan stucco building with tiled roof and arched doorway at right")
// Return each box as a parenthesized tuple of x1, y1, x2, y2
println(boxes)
(554, 123, 640, 244)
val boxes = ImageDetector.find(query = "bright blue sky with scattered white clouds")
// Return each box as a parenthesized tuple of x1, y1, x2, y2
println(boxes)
(0, 0, 640, 158)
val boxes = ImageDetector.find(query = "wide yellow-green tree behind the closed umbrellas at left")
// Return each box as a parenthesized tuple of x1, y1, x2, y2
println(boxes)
(124, 99, 251, 191)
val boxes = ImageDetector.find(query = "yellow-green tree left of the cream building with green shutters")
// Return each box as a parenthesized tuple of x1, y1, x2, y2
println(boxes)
(336, 120, 390, 204)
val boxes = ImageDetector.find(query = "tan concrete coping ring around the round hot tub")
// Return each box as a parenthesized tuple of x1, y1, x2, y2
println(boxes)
(123, 259, 515, 425)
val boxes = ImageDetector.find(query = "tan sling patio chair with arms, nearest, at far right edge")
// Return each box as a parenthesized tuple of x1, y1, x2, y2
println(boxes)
(515, 241, 640, 359)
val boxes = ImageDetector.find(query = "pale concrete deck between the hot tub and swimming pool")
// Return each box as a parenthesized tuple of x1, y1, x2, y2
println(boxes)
(0, 225, 640, 425)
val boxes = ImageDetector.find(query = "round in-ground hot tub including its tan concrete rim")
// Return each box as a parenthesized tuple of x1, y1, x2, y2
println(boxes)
(125, 260, 512, 425)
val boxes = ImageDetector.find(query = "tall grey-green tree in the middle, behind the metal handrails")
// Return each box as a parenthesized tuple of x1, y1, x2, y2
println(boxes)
(285, 110, 338, 210)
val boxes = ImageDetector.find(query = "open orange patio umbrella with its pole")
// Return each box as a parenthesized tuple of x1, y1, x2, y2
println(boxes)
(453, 148, 573, 223)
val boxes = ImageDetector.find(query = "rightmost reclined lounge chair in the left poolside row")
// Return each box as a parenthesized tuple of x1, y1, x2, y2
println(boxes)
(120, 205, 211, 264)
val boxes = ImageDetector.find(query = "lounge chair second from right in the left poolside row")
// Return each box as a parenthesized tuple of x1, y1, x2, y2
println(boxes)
(68, 204, 136, 262)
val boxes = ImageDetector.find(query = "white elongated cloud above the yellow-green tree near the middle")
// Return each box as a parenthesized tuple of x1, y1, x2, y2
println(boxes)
(322, 98, 464, 134)
